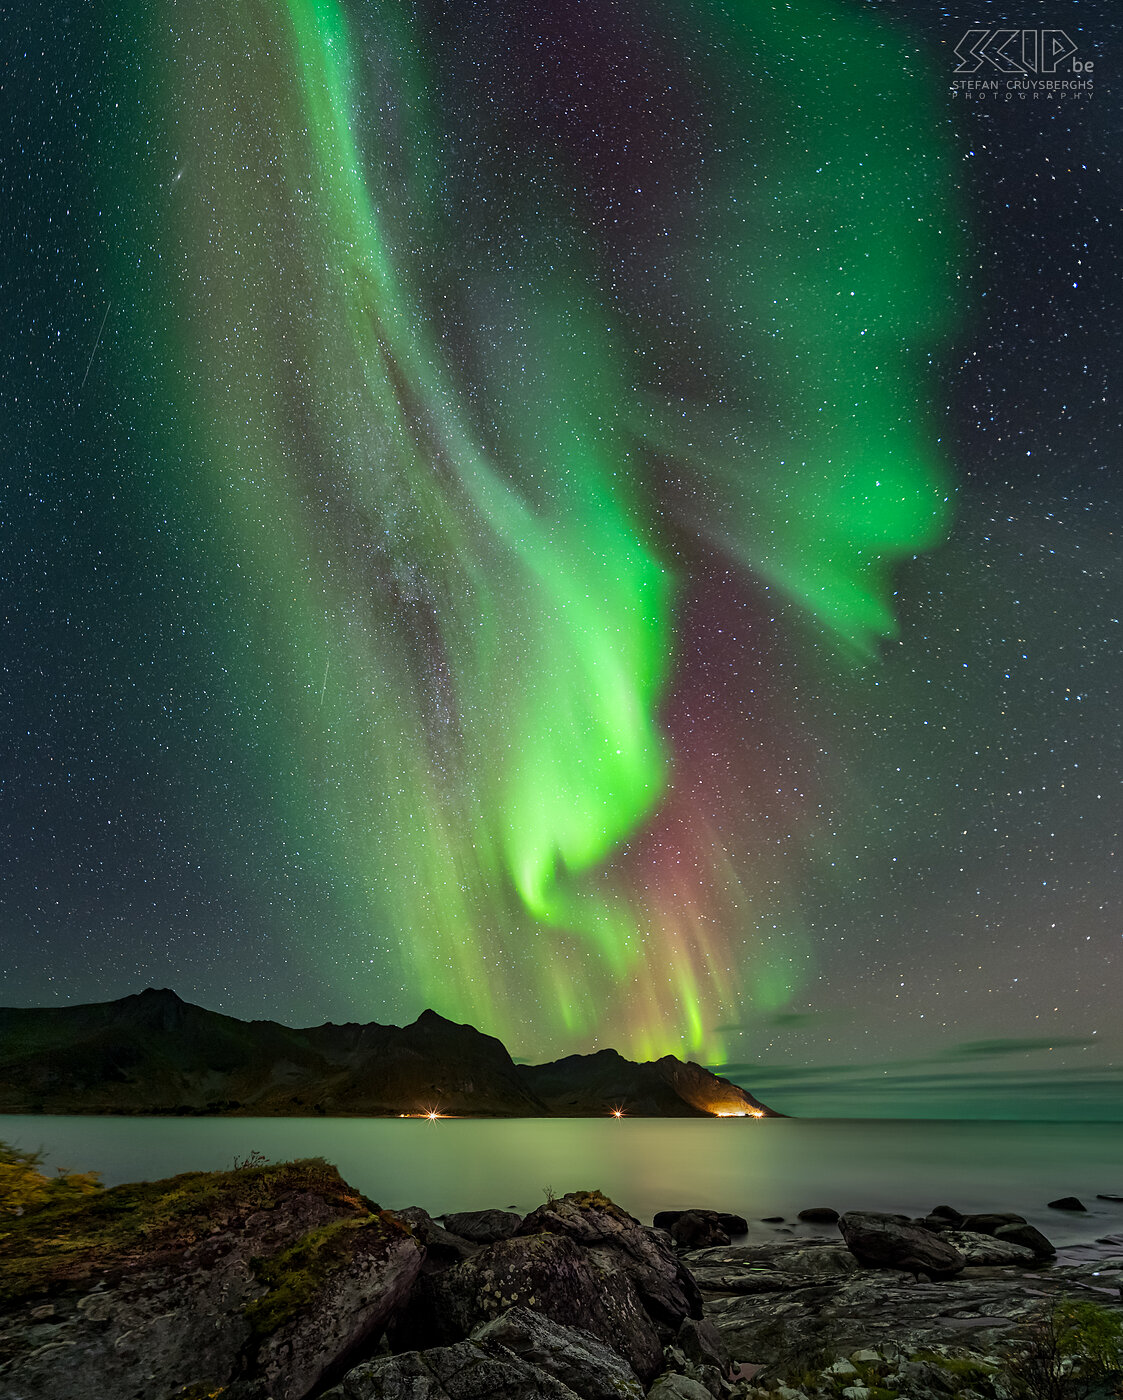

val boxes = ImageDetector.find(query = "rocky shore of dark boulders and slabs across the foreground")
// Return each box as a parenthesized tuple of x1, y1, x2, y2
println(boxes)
(0, 1161, 1123, 1400)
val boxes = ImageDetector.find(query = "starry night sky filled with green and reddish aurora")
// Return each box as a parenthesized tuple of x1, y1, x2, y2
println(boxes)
(0, 0, 1123, 1117)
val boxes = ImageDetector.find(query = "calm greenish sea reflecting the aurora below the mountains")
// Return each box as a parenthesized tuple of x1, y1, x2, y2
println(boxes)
(0, 1116, 1123, 1243)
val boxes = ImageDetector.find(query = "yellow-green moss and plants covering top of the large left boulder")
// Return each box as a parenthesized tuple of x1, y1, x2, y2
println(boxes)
(0, 1158, 372, 1302)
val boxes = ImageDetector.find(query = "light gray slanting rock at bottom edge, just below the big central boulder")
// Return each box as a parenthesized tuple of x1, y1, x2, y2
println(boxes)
(470, 1308, 644, 1400)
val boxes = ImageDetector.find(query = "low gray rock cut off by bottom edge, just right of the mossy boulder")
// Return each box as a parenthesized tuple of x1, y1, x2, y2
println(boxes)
(335, 1341, 581, 1400)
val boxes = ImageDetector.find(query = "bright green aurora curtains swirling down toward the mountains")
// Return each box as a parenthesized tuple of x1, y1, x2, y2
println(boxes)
(126, 0, 958, 1058)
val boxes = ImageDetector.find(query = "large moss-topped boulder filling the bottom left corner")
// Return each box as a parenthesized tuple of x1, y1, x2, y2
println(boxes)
(0, 1162, 421, 1400)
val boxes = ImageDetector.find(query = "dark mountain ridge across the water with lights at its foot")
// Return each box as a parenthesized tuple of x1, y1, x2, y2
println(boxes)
(0, 987, 769, 1117)
